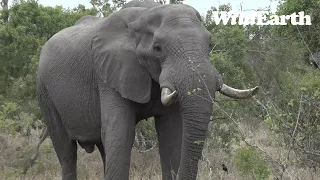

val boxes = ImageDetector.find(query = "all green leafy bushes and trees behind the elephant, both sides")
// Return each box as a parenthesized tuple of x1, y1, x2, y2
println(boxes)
(0, 0, 320, 179)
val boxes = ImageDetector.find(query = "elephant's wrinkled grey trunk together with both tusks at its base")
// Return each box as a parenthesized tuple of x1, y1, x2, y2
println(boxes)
(159, 41, 257, 177)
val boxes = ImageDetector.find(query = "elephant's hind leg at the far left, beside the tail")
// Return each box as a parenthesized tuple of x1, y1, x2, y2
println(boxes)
(39, 85, 77, 180)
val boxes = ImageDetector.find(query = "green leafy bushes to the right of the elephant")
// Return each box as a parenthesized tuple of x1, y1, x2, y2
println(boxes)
(203, 0, 320, 175)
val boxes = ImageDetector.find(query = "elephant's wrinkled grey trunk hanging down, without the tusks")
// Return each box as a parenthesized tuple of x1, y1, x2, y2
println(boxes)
(170, 61, 219, 180)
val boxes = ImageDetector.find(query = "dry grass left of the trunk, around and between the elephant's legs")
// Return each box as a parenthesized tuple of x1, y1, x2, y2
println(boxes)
(0, 132, 161, 180)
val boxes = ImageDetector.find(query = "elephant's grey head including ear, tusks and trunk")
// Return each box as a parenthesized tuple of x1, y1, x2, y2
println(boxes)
(92, 4, 257, 179)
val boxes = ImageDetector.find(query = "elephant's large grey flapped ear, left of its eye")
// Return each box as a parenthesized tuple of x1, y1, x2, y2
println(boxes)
(92, 15, 151, 103)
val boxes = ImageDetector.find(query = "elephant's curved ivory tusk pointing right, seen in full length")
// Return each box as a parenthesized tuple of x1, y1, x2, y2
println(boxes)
(219, 84, 259, 99)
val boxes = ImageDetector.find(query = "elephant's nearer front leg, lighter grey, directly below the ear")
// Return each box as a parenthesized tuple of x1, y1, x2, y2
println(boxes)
(100, 86, 135, 180)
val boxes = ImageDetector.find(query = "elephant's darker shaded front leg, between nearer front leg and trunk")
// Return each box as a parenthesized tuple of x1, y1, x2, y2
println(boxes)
(155, 106, 182, 180)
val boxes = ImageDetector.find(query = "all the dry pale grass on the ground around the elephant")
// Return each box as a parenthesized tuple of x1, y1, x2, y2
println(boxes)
(0, 126, 320, 180)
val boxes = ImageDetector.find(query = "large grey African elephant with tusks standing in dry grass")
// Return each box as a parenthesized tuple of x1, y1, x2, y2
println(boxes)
(37, 2, 258, 180)
